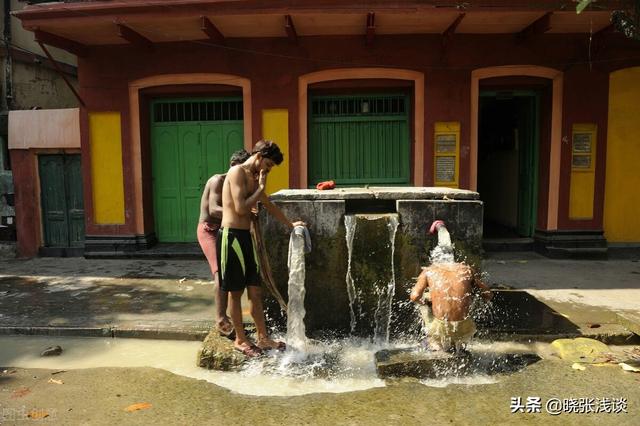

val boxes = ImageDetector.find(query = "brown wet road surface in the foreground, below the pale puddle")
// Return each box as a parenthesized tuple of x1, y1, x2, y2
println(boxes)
(0, 361, 640, 425)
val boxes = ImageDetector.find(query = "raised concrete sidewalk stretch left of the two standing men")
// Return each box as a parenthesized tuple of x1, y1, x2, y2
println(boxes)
(0, 258, 251, 340)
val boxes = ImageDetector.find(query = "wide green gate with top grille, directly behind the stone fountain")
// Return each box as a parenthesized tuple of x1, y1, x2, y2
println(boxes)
(308, 94, 410, 186)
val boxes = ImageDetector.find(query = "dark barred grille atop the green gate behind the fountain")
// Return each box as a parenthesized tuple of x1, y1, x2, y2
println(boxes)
(311, 95, 407, 117)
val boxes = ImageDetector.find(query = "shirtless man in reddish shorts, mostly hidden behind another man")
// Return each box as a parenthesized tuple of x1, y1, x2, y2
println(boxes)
(197, 149, 249, 336)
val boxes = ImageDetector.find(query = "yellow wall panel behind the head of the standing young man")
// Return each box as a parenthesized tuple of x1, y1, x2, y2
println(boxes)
(262, 109, 289, 194)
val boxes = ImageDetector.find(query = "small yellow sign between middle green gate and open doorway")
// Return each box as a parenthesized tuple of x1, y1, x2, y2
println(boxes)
(433, 121, 460, 188)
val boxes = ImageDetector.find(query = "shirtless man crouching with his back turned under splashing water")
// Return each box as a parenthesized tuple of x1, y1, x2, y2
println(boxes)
(409, 221, 493, 350)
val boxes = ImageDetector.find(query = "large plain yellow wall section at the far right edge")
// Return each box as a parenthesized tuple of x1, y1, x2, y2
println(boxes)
(604, 67, 640, 242)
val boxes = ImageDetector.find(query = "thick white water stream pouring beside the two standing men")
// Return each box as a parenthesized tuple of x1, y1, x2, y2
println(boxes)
(287, 227, 307, 352)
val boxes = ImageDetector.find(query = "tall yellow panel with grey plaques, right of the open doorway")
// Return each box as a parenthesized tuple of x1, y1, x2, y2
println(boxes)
(569, 124, 598, 219)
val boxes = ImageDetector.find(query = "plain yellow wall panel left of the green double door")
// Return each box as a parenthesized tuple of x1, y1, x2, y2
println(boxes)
(89, 112, 124, 225)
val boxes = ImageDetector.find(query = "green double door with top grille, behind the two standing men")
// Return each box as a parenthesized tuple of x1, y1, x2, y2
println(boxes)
(151, 98, 244, 242)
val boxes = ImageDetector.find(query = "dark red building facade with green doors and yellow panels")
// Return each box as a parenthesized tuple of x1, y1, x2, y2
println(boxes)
(11, 0, 640, 255)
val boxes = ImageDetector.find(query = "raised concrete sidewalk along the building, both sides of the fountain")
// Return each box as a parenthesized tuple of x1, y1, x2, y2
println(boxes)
(0, 252, 640, 339)
